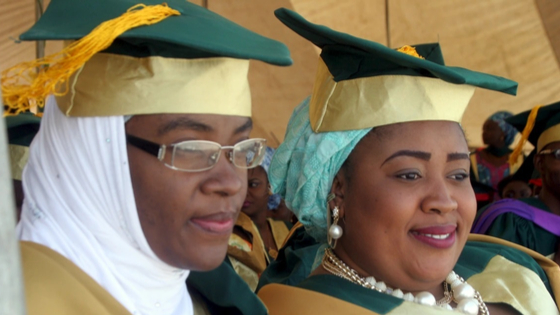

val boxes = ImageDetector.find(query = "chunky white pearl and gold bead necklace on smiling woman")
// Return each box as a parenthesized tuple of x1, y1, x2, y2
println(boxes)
(322, 248, 490, 315)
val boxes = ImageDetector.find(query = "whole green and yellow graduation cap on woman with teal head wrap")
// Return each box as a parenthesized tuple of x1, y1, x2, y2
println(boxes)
(275, 8, 517, 132)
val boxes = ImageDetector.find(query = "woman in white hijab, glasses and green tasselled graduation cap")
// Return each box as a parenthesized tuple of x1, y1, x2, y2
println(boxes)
(6, 0, 291, 314)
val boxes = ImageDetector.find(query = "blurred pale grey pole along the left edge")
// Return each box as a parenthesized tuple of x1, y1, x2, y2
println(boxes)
(0, 91, 26, 315)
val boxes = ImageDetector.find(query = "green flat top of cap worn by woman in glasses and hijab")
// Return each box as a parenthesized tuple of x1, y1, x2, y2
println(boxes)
(20, 0, 292, 66)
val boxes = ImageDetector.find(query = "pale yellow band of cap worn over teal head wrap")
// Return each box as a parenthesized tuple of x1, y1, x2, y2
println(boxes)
(309, 59, 475, 132)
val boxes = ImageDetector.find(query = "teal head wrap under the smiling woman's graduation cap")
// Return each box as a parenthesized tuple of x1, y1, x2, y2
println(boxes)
(268, 98, 371, 242)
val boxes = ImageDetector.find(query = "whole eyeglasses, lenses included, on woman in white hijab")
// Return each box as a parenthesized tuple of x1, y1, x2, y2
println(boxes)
(126, 134, 266, 172)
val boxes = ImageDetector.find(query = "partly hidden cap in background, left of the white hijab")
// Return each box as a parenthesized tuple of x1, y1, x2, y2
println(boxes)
(4, 112, 41, 180)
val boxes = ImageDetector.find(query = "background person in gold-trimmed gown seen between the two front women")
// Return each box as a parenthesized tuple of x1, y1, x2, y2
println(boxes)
(228, 147, 291, 290)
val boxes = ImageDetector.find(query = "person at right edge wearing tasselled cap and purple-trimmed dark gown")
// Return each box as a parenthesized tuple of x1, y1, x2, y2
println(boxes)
(473, 103, 560, 263)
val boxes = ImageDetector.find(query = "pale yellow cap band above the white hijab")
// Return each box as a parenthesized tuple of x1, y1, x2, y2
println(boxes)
(57, 53, 251, 117)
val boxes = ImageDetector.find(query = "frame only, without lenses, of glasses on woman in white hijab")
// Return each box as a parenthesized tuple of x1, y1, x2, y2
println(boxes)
(126, 133, 266, 173)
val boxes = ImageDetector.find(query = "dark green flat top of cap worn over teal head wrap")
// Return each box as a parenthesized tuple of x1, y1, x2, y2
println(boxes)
(274, 8, 517, 95)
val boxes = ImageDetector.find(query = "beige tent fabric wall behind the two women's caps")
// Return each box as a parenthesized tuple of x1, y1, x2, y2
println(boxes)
(4, 0, 560, 146)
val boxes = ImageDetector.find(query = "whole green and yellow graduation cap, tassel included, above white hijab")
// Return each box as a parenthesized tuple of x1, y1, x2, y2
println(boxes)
(2, 0, 292, 116)
